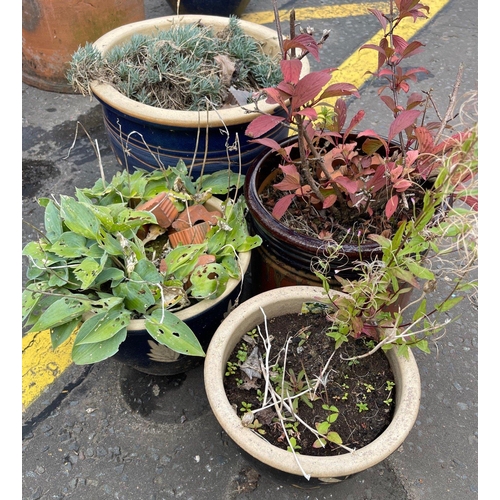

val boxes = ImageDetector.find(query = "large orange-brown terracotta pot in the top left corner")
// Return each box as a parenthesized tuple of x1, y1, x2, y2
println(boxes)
(22, 0, 145, 93)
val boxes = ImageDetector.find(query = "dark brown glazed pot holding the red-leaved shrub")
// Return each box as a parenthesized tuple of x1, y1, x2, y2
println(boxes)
(244, 138, 380, 292)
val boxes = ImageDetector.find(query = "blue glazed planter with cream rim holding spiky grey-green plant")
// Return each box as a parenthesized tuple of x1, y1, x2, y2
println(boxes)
(91, 15, 308, 178)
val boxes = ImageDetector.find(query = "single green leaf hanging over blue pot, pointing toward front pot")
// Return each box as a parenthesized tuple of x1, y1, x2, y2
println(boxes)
(146, 309, 205, 357)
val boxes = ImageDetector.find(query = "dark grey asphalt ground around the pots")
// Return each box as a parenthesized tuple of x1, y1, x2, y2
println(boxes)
(21, 0, 478, 500)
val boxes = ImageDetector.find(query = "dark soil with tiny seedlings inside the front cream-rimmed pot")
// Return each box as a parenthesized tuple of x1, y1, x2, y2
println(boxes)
(224, 314, 395, 456)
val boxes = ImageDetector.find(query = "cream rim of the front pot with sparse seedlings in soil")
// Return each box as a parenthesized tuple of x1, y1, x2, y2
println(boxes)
(204, 286, 421, 482)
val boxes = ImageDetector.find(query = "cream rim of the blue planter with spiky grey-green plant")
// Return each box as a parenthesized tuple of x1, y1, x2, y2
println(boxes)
(90, 14, 300, 128)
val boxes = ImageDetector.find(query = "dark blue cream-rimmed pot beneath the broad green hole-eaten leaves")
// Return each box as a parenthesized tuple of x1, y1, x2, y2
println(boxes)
(113, 252, 251, 376)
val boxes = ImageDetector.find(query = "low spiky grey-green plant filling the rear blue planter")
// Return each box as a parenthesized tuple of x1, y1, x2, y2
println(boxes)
(67, 16, 280, 111)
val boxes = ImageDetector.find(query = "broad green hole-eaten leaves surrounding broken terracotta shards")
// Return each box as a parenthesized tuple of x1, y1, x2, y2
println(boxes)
(22, 162, 260, 364)
